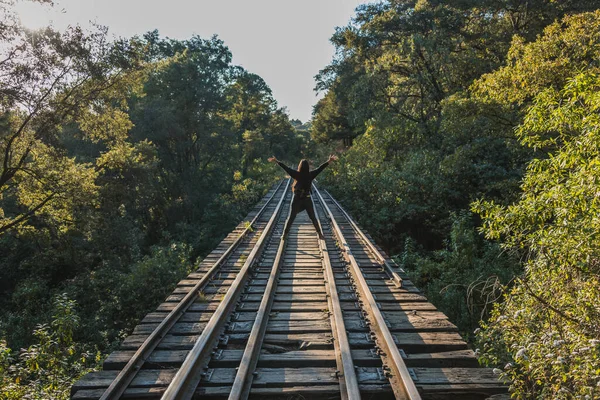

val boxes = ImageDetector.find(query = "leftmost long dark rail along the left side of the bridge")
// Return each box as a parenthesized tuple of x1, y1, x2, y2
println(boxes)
(100, 180, 289, 400)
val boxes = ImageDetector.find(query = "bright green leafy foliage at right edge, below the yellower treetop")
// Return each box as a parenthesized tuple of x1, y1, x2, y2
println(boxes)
(473, 71, 600, 399)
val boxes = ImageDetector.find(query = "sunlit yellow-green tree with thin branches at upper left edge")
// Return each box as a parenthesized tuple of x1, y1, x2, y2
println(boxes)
(0, 2, 141, 235)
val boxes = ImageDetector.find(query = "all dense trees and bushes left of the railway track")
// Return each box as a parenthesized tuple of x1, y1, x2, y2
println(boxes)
(0, 1, 308, 399)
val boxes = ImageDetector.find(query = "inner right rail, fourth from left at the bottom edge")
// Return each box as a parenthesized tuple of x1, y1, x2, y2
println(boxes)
(311, 192, 361, 400)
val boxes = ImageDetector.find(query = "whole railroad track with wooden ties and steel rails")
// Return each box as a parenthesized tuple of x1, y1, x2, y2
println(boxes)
(72, 180, 506, 400)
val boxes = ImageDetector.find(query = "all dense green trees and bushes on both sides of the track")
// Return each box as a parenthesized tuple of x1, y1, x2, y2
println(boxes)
(0, 0, 600, 399)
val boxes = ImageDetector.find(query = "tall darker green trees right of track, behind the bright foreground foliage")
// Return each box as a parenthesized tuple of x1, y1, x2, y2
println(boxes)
(312, 0, 600, 340)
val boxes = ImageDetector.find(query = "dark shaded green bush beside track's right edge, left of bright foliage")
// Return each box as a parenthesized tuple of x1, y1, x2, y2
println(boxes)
(404, 212, 520, 339)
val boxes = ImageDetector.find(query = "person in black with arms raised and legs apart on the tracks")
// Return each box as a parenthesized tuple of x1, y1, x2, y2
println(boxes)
(269, 155, 338, 239)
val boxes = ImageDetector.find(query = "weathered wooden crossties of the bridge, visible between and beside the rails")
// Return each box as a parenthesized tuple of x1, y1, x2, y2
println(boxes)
(72, 182, 506, 400)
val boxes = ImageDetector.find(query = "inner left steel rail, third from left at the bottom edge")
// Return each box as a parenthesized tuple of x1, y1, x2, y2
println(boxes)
(229, 189, 292, 400)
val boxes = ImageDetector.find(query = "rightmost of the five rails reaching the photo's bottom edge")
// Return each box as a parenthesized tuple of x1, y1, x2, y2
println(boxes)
(314, 186, 421, 400)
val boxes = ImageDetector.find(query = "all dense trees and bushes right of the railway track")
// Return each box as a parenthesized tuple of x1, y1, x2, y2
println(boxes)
(312, 0, 600, 399)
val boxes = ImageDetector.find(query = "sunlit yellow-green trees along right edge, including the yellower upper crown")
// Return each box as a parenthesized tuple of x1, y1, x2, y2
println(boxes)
(473, 11, 600, 399)
